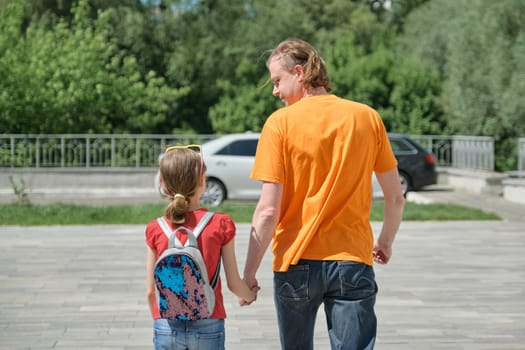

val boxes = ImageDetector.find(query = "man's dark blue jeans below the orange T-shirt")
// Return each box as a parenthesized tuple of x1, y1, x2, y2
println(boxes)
(274, 260, 377, 350)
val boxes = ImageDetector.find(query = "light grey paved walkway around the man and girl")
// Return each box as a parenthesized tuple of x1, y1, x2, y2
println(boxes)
(0, 191, 525, 350)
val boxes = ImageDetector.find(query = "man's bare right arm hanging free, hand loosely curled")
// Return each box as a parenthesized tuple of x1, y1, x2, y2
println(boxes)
(373, 168, 405, 264)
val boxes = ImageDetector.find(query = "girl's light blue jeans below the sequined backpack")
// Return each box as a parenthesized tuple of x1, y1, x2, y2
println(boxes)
(153, 318, 224, 350)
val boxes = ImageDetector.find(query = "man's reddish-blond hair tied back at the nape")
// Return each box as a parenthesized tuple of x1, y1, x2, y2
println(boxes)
(266, 38, 332, 91)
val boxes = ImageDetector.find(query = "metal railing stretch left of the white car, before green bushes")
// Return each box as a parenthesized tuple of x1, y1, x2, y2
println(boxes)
(0, 134, 216, 168)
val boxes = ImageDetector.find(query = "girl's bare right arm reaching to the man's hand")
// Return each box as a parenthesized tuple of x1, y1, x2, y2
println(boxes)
(221, 239, 260, 302)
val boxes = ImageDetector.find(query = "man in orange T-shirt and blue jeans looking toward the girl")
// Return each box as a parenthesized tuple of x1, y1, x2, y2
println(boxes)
(244, 39, 404, 350)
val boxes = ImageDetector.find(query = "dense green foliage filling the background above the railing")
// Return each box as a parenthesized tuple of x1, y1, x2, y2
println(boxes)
(0, 0, 525, 170)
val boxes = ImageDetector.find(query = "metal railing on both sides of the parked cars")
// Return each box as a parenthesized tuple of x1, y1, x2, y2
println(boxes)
(0, 134, 500, 171)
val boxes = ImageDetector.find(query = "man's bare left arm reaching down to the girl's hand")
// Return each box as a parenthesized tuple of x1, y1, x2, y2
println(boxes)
(244, 182, 283, 288)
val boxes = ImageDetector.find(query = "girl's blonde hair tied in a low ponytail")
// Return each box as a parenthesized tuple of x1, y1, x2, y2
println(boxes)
(159, 149, 205, 224)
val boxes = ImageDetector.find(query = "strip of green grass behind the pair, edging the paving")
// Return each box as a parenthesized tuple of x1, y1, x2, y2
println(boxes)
(0, 201, 501, 225)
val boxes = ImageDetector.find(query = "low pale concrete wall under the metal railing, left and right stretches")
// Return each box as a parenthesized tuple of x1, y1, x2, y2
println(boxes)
(0, 168, 525, 204)
